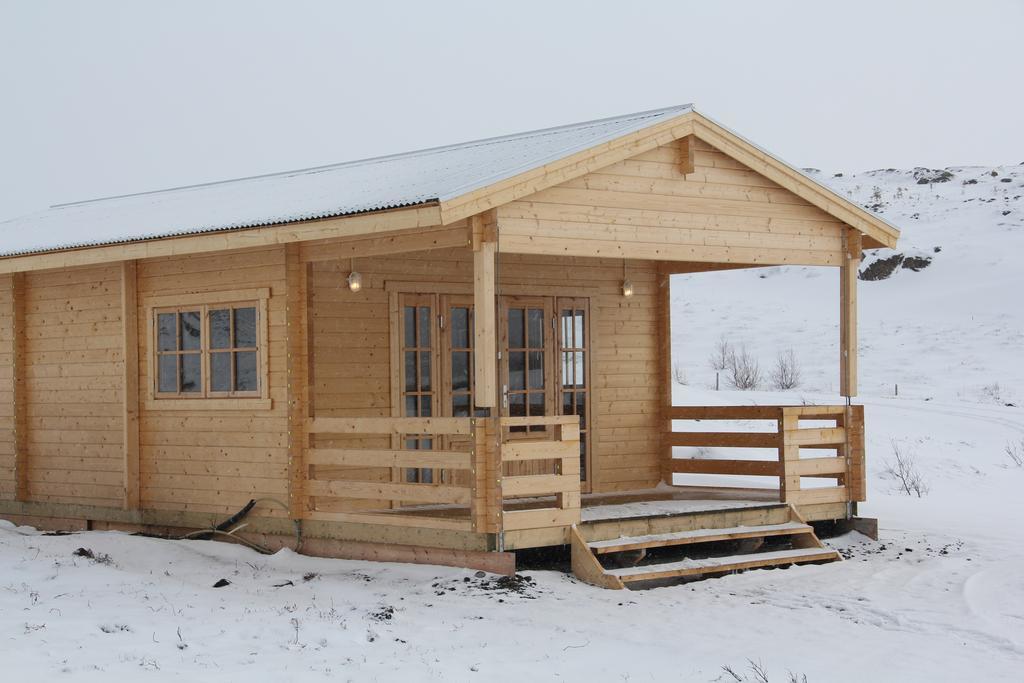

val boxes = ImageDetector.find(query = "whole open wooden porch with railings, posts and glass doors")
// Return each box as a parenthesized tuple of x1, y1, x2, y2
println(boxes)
(290, 212, 864, 552)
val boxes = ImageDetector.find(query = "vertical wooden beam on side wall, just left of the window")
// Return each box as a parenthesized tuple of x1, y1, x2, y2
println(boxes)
(121, 261, 140, 510)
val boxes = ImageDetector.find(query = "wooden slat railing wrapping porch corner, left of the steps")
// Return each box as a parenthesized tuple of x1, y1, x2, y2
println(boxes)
(303, 416, 581, 533)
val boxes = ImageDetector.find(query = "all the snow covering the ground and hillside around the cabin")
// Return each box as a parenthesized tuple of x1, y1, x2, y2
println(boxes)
(0, 162, 1024, 683)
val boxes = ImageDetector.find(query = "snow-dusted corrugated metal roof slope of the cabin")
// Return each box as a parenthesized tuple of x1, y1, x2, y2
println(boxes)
(0, 104, 691, 256)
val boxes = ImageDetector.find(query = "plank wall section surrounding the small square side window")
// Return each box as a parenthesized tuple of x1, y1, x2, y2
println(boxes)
(136, 247, 288, 516)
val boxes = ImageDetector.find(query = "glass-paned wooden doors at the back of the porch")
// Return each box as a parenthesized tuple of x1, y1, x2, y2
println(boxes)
(397, 294, 591, 489)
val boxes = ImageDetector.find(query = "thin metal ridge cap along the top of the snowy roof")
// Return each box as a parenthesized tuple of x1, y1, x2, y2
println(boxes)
(49, 103, 693, 209)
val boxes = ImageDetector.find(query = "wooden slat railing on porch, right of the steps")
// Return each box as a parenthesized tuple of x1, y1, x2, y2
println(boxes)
(664, 405, 865, 505)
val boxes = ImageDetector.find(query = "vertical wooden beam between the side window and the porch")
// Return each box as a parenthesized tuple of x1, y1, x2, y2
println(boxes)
(285, 244, 312, 519)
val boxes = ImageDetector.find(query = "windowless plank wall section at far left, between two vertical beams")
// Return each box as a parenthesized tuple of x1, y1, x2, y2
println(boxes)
(25, 264, 124, 507)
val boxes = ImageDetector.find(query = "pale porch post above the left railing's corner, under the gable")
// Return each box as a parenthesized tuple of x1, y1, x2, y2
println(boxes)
(469, 212, 498, 409)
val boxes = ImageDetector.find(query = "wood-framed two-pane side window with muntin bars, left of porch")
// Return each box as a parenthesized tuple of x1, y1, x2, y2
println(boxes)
(148, 290, 269, 408)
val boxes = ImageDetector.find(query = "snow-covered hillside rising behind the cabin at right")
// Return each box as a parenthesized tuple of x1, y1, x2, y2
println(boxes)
(673, 160, 1024, 403)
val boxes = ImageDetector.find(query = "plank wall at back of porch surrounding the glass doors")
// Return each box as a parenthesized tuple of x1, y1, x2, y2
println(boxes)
(312, 250, 659, 499)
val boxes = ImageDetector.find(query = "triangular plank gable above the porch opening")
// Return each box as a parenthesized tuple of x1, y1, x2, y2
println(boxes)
(498, 138, 843, 265)
